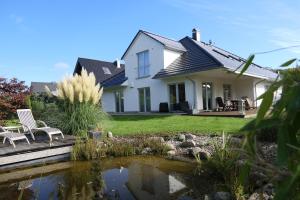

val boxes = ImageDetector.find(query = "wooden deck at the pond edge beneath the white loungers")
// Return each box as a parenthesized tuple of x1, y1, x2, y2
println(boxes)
(0, 135, 75, 168)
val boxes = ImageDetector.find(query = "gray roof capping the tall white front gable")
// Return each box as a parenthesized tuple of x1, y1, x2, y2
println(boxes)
(122, 30, 186, 59)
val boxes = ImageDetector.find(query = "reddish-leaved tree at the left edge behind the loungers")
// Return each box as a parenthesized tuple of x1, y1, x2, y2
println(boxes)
(0, 77, 30, 120)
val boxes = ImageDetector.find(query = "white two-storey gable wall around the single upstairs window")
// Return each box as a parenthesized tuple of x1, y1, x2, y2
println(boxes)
(123, 33, 185, 112)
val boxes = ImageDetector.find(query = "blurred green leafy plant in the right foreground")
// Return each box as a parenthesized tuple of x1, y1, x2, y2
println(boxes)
(242, 55, 300, 199)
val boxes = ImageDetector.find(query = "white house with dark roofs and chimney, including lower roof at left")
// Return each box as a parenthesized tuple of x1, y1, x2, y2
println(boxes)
(74, 29, 277, 112)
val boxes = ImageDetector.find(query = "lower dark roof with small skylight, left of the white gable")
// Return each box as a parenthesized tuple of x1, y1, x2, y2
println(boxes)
(74, 58, 125, 87)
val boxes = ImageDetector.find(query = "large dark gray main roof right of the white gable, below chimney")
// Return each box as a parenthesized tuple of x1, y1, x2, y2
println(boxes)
(153, 37, 277, 79)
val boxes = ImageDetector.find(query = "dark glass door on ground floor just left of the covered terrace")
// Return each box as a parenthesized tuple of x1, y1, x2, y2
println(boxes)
(169, 83, 186, 110)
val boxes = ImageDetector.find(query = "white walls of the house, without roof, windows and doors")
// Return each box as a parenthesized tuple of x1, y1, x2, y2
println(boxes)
(102, 32, 269, 112)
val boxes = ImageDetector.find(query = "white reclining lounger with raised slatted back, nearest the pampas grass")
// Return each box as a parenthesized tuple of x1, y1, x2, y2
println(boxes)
(17, 109, 64, 143)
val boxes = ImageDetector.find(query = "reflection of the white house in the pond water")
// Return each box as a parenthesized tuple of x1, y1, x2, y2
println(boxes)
(126, 163, 186, 200)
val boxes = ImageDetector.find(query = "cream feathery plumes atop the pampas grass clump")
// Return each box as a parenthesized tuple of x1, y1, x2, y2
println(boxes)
(57, 68, 103, 105)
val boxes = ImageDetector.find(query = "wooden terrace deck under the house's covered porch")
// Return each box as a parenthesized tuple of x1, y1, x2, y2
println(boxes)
(196, 109, 257, 118)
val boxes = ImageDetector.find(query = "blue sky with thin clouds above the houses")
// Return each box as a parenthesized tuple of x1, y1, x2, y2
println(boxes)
(0, 0, 300, 84)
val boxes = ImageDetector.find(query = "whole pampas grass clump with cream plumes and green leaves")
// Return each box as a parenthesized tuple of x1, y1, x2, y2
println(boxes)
(57, 69, 107, 136)
